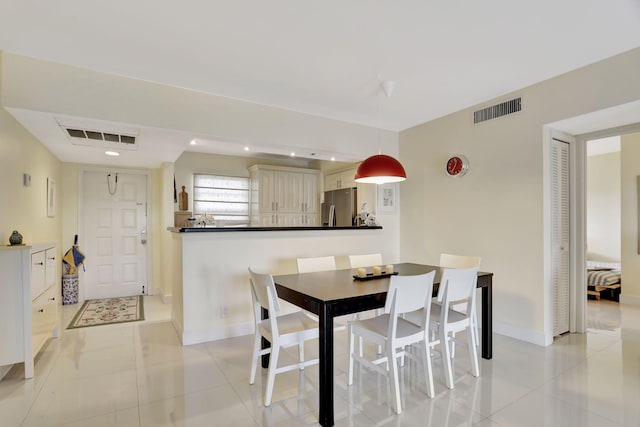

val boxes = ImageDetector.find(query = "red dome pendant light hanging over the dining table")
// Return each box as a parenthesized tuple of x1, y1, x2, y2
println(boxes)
(355, 76, 407, 184)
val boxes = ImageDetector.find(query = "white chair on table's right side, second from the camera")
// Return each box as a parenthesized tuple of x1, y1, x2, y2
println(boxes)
(430, 267, 480, 389)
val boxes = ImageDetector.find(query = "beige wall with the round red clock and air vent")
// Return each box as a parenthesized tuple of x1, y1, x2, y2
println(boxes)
(400, 49, 640, 344)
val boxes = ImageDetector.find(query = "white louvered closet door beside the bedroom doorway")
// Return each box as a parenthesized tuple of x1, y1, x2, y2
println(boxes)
(551, 139, 570, 336)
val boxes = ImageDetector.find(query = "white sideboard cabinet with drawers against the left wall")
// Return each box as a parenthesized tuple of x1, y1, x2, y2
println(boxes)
(0, 243, 60, 378)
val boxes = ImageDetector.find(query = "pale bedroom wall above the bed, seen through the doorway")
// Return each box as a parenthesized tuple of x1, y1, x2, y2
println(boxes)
(587, 151, 620, 262)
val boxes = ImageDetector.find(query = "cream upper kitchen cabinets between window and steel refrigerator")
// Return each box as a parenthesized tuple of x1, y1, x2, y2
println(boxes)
(249, 165, 320, 227)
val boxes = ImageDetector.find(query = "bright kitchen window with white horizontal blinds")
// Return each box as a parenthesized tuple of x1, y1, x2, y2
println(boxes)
(193, 174, 249, 221)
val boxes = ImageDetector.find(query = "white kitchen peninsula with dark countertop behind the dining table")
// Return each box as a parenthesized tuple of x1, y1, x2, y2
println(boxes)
(168, 227, 392, 345)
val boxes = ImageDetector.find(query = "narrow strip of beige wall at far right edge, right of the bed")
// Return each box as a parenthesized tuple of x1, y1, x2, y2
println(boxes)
(620, 133, 640, 304)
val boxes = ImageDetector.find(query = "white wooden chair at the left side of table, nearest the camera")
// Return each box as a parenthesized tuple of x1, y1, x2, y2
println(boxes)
(249, 268, 319, 406)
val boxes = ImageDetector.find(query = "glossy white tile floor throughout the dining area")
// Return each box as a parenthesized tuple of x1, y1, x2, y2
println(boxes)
(0, 297, 640, 427)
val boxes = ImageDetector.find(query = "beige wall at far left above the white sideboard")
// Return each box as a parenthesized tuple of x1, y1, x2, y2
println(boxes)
(0, 51, 64, 254)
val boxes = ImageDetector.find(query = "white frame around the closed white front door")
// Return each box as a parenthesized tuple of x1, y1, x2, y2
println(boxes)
(76, 165, 155, 301)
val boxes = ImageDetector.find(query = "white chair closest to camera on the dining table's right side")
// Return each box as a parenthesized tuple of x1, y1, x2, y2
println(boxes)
(348, 271, 435, 414)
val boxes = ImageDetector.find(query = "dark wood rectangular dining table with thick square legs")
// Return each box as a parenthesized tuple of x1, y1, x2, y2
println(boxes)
(262, 263, 493, 426)
